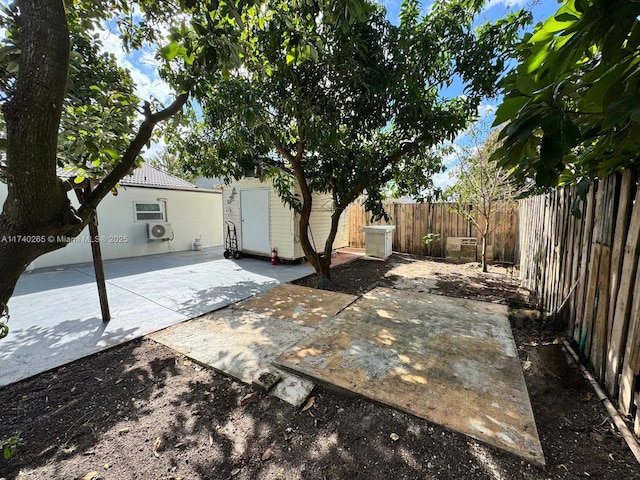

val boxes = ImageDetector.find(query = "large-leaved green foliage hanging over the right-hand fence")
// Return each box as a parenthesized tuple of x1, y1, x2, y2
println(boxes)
(494, 0, 640, 186)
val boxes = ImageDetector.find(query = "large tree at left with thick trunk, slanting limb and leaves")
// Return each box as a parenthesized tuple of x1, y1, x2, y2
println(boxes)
(0, 0, 370, 333)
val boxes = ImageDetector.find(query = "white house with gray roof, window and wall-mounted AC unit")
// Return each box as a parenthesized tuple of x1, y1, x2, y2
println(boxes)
(0, 164, 223, 268)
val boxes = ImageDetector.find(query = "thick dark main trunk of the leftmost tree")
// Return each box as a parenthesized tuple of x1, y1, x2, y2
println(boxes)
(0, 0, 74, 313)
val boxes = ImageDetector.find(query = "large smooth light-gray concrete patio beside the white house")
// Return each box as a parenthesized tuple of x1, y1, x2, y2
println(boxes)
(0, 248, 313, 385)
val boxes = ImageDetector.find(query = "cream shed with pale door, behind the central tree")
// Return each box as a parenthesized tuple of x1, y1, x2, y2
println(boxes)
(222, 177, 349, 260)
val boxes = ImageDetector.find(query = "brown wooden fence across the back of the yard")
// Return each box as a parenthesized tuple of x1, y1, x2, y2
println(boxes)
(349, 203, 518, 263)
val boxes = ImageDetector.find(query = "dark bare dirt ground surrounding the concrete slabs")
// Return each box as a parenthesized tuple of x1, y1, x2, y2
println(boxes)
(0, 255, 640, 480)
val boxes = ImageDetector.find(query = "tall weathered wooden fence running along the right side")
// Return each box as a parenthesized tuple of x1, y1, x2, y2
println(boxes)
(520, 170, 640, 435)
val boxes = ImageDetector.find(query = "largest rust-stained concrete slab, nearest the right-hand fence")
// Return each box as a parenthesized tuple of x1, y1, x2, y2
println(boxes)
(275, 288, 544, 465)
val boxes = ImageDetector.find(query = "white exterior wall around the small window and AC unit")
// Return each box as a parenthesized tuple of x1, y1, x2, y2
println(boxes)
(0, 183, 223, 268)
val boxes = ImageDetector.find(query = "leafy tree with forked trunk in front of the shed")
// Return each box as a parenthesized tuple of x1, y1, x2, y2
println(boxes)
(172, 0, 528, 285)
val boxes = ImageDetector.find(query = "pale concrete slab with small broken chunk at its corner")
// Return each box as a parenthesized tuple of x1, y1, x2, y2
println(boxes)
(149, 308, 314, 407)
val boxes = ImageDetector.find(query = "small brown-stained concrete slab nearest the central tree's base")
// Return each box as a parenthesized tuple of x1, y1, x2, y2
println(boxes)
(236, 284, 357, 327)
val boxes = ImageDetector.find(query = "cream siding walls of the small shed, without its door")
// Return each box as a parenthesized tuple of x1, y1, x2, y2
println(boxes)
(222, 177, 349, 260)
